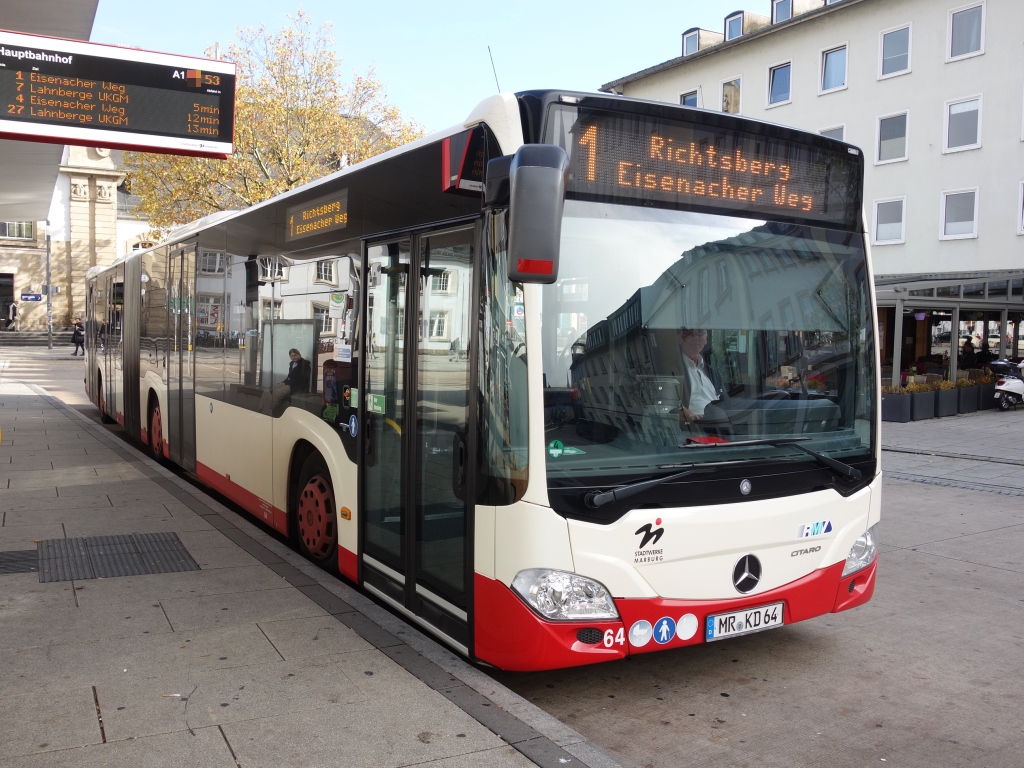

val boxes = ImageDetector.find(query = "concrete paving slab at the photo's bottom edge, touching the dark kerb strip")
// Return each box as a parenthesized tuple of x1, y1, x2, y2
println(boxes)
(223, 694, 512, 768)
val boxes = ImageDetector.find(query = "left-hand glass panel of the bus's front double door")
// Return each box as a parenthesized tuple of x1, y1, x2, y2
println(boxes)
(361, 240, 412, 572)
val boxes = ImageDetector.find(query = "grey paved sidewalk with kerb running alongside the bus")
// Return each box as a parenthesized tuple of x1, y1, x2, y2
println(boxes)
(0, 370, 622, 768)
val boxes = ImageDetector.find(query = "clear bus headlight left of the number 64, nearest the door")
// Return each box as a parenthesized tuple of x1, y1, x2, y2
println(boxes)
(512, 568, 618, 621)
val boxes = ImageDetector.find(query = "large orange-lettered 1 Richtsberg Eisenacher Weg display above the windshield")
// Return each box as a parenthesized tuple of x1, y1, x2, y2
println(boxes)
(552, 110, 862, 228)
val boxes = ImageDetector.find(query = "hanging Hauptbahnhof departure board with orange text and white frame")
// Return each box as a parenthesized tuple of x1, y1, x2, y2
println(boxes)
(0, 31, 234, 158)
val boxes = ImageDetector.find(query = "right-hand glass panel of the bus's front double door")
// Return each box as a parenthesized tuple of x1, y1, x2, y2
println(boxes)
(416, 229, 473, 607)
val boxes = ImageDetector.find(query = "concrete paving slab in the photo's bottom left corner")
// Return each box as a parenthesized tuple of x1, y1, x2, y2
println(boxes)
(0, 685, 102, 756)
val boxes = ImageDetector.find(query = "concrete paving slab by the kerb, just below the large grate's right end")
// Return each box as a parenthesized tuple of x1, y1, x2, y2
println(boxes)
(161, 585, 327, 632)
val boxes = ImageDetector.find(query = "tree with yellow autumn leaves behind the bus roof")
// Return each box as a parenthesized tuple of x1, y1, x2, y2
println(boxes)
(124, 10, 423, 232)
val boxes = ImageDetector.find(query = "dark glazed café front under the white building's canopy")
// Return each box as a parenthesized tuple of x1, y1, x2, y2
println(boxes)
(876, 270, 1024, 387)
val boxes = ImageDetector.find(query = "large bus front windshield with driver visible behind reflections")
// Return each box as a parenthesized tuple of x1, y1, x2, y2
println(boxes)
(542, 201, 876, 484)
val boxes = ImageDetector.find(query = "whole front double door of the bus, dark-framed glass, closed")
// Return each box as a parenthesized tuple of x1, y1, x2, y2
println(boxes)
(361, 227, 476, 648)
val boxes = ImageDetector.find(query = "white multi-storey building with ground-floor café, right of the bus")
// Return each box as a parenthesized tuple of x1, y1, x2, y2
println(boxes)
(602, 0, 1024, 370)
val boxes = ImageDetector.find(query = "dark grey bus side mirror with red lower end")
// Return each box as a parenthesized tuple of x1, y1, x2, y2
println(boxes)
(503, 144, 569, 284)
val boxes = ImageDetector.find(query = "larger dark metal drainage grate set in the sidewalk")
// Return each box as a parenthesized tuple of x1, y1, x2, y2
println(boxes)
(37, 532, 200, 583)
